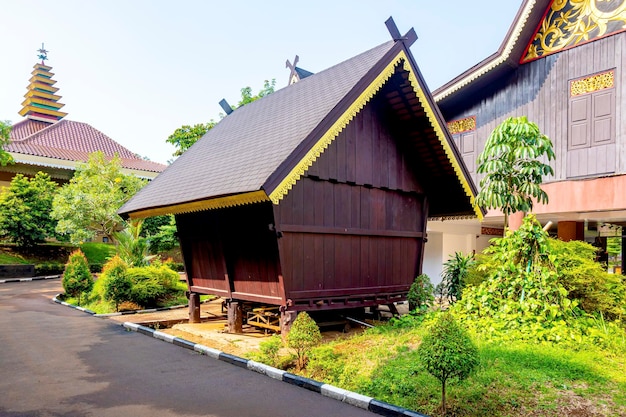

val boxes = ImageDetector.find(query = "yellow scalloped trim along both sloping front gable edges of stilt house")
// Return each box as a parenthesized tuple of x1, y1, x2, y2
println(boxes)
(269, 51, 483, 220)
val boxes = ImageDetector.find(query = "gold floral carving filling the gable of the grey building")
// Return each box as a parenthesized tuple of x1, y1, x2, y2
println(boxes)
(521, 0, 626, 63)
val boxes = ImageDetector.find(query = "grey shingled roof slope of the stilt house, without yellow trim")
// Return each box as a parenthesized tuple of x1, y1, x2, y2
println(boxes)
(121, 41, 394, 213)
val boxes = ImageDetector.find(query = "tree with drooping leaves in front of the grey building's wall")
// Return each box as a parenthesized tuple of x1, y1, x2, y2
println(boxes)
(476, 116, 555, 230)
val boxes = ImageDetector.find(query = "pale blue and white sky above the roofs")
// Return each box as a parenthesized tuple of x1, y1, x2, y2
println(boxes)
(0, 0, 521, 163)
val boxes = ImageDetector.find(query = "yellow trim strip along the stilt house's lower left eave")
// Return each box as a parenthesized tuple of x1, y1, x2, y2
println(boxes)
(128, 190, 269, 219)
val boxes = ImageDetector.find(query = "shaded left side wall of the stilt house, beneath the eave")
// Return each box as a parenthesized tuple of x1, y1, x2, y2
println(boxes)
(176, 202, 281, 302)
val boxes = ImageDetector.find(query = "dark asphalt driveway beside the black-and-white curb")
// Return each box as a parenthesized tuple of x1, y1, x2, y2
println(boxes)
(0, 280, 374, 417)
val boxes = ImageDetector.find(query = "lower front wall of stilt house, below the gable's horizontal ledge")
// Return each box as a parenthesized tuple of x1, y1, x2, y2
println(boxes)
(274, 177, 425, 298)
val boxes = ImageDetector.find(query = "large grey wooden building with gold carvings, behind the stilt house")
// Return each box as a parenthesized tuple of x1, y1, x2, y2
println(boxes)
(427, 0, 626, 275)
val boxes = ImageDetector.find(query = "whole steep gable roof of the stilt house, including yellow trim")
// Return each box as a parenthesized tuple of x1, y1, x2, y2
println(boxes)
(119, 35, 482, 217)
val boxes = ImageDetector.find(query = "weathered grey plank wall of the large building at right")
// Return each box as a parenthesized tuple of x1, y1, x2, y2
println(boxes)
(440, 33, 626, 184)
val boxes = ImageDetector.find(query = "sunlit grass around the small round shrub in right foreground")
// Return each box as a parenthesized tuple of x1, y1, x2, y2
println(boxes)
(294, 326, 626, 417)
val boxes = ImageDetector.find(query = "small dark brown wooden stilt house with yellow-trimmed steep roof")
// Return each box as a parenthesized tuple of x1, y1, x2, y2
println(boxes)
(120, 19, 481, 332)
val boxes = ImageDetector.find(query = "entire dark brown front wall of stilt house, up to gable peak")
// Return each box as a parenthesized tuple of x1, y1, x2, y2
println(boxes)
(274, 99, 426, 299)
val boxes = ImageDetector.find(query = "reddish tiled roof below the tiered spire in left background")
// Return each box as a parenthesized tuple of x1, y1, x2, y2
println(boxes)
(5, 119, 165, 172)
